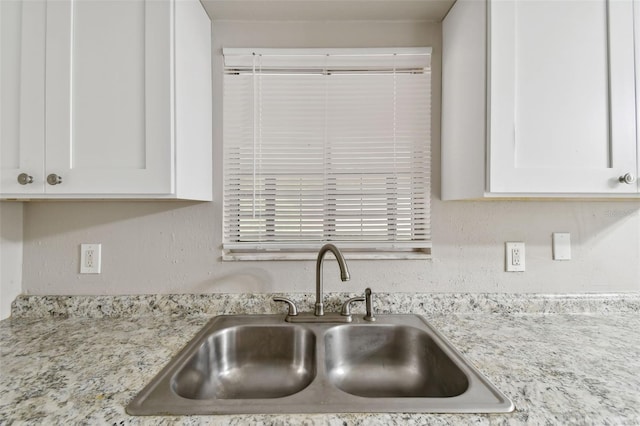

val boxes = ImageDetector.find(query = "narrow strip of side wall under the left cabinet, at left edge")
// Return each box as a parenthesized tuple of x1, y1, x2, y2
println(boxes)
(0, 202, 23, 320)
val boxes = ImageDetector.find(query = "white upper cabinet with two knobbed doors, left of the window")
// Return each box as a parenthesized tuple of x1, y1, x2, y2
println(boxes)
(0, 0, 212, 200)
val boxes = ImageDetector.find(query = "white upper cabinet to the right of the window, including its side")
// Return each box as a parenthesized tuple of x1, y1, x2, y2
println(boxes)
(442, 0, 638, 199)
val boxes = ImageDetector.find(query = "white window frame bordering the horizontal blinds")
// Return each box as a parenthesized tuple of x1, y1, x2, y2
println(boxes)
(222, 48, 432, 260)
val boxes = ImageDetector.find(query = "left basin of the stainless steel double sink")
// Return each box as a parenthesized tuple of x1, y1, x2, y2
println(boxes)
(172, 325, 315, 399)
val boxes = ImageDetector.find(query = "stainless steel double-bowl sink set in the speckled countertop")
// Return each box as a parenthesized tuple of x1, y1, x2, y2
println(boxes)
(127, 315, 514, 415)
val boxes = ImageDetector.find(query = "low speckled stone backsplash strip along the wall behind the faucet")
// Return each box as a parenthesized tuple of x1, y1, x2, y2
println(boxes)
(12, 293, 640, 318)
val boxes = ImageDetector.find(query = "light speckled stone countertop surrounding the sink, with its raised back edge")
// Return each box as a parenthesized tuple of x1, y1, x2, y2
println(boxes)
(0, 293, 640, 425)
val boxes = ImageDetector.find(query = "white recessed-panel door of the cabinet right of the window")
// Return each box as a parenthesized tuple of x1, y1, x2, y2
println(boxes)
(489, 0, 638, 193)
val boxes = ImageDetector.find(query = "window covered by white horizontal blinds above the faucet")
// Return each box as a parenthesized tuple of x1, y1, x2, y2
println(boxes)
(223, 48, 431, 259)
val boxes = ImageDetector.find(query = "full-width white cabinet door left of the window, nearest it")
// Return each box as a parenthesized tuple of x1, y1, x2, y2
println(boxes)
(45, 0, 174, 194)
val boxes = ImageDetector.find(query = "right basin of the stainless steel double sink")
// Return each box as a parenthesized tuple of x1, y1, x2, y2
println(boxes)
(324, 325, 469, 398)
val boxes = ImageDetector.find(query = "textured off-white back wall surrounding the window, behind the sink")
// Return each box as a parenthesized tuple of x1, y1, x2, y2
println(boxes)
(23, 21, 640, 294)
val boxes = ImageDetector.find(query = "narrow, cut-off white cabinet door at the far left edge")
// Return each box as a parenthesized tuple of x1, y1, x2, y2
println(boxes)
(0, 0, 45, 196)
